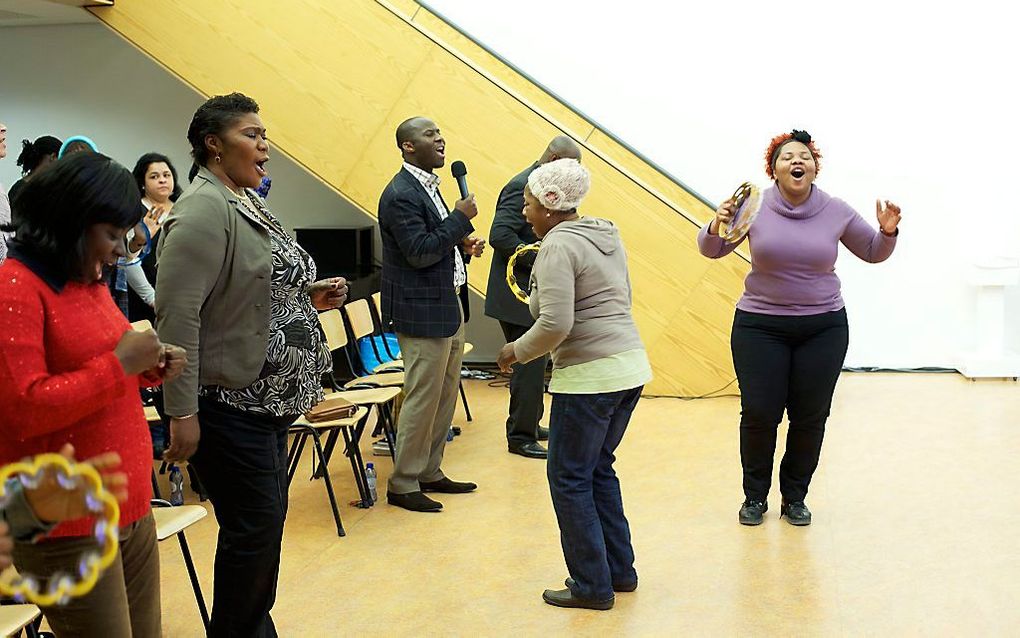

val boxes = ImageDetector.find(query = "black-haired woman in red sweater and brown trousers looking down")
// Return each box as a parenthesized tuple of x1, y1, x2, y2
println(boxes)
(0, 153, 185, 637)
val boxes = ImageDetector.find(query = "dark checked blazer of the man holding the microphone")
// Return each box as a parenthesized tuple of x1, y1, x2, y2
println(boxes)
(378, 168, 474, 337)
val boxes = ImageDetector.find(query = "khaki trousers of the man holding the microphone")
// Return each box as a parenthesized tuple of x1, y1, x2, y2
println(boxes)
(389, 310, 464, 494)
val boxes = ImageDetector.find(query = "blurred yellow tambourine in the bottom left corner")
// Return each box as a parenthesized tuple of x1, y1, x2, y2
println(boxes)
(0, 454, 120, 607)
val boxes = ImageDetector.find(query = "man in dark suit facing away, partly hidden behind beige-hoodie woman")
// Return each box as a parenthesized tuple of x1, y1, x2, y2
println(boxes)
(486, 135, 580, 458)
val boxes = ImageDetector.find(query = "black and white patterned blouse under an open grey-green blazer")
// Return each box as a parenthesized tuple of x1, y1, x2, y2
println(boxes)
(201, 191, 333, 416)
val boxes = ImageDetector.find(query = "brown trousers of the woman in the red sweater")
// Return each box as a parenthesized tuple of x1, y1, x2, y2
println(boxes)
(14, 512, 162, 638)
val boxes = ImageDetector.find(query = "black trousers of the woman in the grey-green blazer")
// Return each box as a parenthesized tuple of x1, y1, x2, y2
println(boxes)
(191, 397, 297, 638)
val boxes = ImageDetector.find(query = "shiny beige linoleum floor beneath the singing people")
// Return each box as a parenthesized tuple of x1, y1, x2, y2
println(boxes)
(145, 374, 1020, 636)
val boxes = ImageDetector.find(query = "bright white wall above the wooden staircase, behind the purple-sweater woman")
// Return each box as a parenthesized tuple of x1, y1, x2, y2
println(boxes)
(426, 0, 1020, 366)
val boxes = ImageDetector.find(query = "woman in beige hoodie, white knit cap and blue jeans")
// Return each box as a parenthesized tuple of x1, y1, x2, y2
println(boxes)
(499, 159, 652, 609)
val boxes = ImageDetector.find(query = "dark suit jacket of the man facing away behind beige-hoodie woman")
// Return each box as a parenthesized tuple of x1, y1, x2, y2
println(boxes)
(486, 162, 539, 327)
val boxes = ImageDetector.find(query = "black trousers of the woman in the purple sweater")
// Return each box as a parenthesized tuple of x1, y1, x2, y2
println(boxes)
(730, 308, 850, 502)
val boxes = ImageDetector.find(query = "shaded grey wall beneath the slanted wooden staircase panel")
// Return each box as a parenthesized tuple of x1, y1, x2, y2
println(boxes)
(0, 19, 518, 361)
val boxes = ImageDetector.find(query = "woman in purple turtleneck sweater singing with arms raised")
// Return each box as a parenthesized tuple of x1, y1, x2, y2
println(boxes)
(698, 131, 900, 525)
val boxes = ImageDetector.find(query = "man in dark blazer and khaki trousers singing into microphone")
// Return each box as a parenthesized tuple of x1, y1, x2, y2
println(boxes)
(378, 117, 486, 511)
